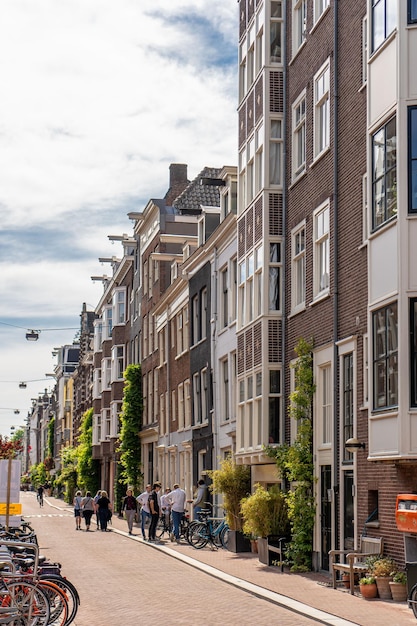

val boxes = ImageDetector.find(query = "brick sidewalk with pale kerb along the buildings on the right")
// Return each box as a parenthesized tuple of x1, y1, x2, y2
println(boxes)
(44, 498, 416, 626)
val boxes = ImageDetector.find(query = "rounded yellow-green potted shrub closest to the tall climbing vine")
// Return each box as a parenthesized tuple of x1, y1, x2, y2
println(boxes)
(241, 483, 289, 565)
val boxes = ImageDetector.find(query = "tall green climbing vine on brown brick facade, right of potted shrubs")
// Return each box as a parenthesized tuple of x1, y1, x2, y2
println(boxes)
(266, 339, 316, 571)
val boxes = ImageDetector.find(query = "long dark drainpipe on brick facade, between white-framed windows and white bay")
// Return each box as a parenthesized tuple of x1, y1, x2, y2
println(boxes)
(333, 0, 340, 546)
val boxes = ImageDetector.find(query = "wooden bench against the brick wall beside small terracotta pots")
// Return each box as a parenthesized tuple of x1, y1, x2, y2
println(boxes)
(329, 536, 384, 595)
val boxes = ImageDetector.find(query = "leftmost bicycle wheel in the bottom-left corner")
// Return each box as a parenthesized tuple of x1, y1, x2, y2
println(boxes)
(7, 581, 50, 626)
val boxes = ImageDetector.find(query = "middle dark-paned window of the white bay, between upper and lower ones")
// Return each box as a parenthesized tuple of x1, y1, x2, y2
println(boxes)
(372, 117, 397, 229)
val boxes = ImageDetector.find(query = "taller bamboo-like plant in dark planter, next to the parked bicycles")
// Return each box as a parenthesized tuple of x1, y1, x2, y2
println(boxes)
(207, 456, 251, 552)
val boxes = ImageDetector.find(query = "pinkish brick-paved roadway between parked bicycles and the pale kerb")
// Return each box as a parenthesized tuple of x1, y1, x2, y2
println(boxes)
(17, 493, 317, 626)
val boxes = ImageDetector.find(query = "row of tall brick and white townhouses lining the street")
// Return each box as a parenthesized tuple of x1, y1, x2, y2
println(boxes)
(26, 0, 417, 570)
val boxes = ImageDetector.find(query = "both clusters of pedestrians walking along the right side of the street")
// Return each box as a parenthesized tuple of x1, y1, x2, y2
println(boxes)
(74, 480, 208, 543)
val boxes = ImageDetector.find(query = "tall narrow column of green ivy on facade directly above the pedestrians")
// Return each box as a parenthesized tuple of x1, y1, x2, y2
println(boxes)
(116, 364, 143, 497)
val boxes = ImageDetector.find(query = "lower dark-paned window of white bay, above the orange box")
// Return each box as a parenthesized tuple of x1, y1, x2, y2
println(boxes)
(372, 302, 398, 410)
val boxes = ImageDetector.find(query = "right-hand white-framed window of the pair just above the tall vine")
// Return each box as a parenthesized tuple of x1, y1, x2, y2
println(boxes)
(314, 204, 330, 296)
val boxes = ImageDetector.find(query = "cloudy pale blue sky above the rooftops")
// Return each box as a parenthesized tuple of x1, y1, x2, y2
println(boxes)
(0, 0, 238, 436)
